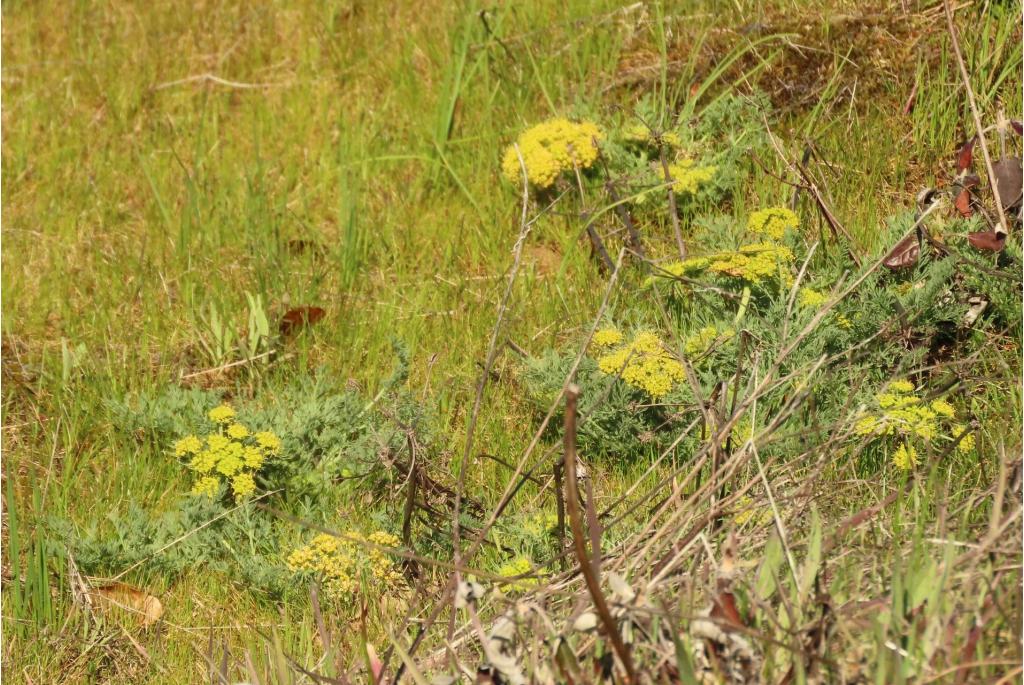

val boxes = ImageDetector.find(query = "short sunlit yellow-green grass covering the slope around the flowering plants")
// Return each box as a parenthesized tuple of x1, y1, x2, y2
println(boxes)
(2, 0, 1021, 683)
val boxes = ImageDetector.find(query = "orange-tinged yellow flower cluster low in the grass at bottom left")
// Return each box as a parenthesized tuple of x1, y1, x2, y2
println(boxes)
(286, 531, 402, 601)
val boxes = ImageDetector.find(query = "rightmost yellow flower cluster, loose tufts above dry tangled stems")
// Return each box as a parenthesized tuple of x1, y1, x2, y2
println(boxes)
(854, 380, 975, 471)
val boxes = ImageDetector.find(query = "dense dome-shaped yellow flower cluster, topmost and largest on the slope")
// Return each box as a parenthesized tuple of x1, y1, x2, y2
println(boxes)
(502, 119, 604, 188)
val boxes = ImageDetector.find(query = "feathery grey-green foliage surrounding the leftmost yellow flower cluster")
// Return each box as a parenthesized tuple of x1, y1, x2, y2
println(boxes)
(58, 342, 444, 597)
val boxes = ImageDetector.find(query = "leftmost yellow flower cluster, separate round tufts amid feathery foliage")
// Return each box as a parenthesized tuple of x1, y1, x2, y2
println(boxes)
(174, 404, 281, 501)
